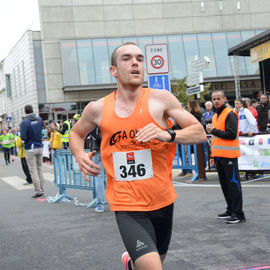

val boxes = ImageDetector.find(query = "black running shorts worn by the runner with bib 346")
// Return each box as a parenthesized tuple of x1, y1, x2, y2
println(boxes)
(115, 204, 174, 262)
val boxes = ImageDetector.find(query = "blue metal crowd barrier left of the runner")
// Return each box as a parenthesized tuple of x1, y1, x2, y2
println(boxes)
(53, 149, 96, 208)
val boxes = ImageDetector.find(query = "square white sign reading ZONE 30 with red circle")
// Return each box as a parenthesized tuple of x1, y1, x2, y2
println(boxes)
(145, 44, 169, 74)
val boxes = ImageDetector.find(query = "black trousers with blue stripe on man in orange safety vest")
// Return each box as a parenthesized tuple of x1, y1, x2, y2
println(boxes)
(215, 157, 244, 218)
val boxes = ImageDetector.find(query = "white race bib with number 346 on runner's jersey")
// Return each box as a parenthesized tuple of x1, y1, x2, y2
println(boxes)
(113, 149, 154, 181)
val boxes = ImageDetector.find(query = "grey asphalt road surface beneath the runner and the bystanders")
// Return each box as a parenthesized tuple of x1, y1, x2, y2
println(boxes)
(0, 156, 270, 270)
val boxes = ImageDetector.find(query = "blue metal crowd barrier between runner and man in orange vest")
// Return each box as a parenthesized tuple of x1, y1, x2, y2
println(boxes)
(173, 144, 199, 181)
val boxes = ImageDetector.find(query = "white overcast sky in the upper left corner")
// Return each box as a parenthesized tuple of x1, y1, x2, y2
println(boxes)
(0, 0, 40, 61)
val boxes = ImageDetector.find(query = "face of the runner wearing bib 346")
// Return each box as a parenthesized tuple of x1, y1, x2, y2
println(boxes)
(110, 45, 144, 86)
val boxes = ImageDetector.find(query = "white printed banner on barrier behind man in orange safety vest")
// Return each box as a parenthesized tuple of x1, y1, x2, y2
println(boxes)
(238, 134, 270, 171)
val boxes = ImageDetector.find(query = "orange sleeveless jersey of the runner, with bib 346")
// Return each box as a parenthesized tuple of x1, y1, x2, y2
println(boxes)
(100, 88, 177, 211)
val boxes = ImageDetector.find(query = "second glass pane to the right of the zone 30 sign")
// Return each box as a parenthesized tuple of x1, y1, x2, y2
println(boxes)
(183, 35, 199, 74)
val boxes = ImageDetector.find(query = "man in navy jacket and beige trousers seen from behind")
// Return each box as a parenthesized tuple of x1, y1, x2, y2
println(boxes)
(20, 105, 44, 198)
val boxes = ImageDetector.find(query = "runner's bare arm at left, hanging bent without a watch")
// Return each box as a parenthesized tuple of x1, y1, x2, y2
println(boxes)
(69, 100, 103, 180)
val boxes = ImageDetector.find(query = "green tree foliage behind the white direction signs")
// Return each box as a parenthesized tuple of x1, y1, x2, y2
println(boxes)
(171, 77, 211, 108)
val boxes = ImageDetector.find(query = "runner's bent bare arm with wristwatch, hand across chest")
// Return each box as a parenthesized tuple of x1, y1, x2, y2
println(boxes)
(137, 90, 206, 144)
